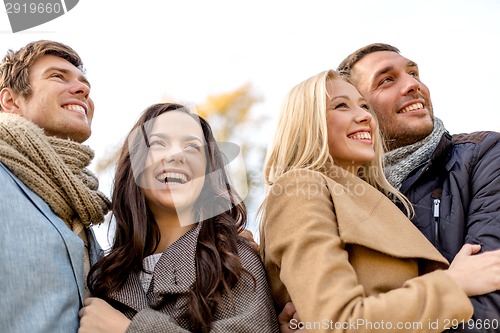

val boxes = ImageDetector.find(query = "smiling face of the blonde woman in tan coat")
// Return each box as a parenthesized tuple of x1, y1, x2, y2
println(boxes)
(326, 79, 376, 170)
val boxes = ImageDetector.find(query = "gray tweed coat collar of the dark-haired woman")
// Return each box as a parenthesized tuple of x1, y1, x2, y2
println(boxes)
(111, 222, 203, 311)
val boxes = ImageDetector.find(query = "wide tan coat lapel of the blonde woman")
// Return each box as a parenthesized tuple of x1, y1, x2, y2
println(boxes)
(327, 166, 448, 264)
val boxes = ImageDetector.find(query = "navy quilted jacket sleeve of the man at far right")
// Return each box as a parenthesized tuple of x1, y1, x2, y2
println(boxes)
(456, 133, 500, 332)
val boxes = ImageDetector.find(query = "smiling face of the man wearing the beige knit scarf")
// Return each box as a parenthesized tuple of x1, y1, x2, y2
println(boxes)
(13, 55, 94, 142)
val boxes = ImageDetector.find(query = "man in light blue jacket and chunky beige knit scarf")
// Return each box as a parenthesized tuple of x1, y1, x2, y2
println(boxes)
(0, 41, 110, 333)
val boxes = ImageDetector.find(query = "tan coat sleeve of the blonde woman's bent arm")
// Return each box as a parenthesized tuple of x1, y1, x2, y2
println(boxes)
(261, 171, 472, 333)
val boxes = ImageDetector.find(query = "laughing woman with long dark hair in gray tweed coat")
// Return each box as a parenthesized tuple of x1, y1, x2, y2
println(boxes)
(80, 103, 278, 333)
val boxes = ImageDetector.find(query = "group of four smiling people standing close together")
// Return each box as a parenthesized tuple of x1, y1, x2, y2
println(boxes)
(0, 41, 500, 333)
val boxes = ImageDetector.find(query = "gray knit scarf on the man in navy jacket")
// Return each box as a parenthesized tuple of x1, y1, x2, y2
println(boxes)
(384, 117, 446, 190)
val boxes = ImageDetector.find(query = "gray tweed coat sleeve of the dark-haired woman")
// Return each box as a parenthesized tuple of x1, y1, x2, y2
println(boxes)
(127, 244, 279, 333)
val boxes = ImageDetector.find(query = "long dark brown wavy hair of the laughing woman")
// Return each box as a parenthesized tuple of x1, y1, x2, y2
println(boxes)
(87, 103, 248, 332)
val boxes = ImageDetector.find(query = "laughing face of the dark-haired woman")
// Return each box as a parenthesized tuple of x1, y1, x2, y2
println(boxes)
(142, 111, 207, 215)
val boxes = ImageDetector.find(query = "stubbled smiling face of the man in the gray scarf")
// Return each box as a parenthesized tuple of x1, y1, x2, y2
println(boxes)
(351, 51, 434, 149)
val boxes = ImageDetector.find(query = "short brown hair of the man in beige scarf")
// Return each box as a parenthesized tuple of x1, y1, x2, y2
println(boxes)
(0, 40, 84, 106)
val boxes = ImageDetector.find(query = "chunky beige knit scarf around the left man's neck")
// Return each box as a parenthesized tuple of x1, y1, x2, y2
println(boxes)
(0, 112, 111, 236)
